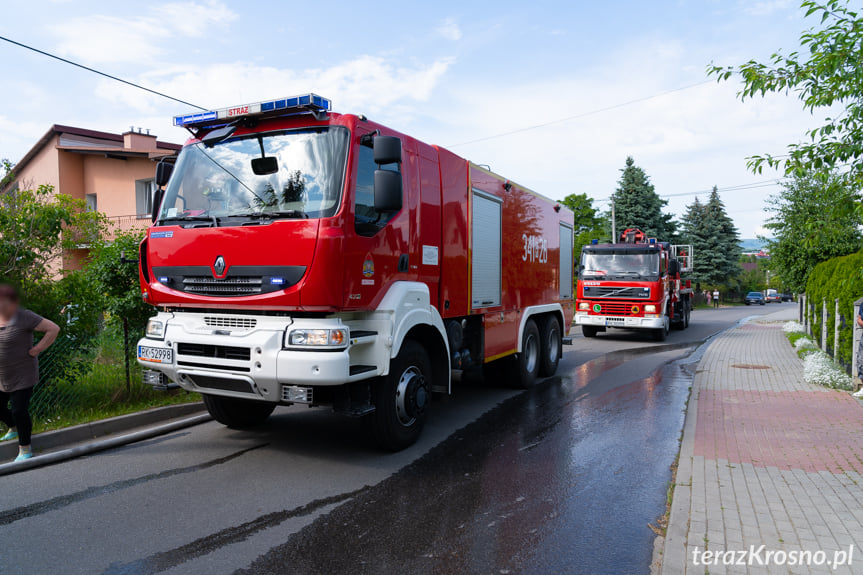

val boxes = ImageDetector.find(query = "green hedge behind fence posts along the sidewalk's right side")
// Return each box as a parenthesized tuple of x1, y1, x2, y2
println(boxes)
(806, 251, 863, 366)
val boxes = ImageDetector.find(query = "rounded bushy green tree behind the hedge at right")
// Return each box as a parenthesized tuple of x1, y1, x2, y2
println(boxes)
(765, 171, 863, 292)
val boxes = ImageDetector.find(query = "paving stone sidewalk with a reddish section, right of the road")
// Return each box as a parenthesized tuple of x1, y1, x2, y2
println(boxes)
(661, 306, 863, 575)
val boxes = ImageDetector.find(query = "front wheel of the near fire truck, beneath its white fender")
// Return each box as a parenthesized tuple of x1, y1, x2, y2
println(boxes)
(369, 339, 432, 451)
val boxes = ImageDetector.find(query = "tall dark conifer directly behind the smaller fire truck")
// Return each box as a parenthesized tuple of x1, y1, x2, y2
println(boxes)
(609, 156, 676, 241)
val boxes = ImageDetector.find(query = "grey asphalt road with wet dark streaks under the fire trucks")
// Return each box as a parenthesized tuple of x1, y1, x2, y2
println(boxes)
(0, 304, 793, 575)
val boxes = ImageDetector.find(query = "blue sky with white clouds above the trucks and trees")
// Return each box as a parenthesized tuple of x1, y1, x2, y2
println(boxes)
(0, 0, 818, 237)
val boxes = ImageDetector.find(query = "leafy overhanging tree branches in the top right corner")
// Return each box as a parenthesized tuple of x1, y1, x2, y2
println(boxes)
(708, 0, 863, 189)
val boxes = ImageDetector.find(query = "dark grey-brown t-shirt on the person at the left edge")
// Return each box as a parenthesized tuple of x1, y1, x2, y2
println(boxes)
(0, 309, 42, 393)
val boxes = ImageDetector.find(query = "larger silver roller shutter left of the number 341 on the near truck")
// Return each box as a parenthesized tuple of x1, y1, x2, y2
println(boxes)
(470, 190, 501, 309)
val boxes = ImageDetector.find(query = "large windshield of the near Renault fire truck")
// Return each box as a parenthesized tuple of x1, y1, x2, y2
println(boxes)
(159, 127, 349, 225)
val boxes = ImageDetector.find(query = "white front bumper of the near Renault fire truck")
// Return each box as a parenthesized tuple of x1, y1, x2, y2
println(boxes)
(138, 313, 380, 402)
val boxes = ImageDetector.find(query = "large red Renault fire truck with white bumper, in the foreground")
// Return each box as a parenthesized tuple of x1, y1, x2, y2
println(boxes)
(138, 94, 573, 450)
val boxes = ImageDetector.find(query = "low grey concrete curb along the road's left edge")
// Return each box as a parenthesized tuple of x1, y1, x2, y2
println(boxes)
(0, 403, 205, 464)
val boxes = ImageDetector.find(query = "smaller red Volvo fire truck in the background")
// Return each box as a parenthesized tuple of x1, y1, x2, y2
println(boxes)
(575, 229, 693, 341)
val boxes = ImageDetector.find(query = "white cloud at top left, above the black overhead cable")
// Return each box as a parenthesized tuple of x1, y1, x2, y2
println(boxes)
(49, 0, 236, 63)
